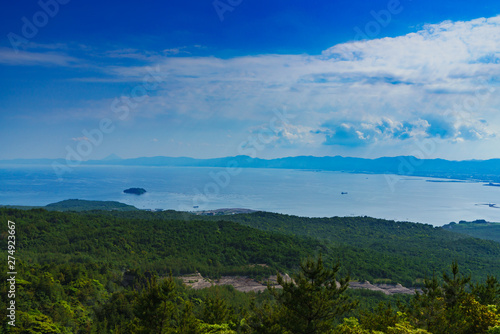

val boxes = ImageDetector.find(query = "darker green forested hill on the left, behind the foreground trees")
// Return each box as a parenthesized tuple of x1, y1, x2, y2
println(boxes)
(0, 209, 326, 277)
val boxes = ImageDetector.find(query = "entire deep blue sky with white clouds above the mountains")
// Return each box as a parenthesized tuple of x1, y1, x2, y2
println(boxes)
(0, 0, 500, 160)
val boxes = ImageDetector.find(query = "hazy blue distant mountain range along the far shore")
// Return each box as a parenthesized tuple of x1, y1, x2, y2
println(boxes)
(0, 155, 500, 181)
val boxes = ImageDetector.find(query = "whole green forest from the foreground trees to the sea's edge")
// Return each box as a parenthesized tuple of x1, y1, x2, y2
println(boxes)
(0, 207, 500, 334)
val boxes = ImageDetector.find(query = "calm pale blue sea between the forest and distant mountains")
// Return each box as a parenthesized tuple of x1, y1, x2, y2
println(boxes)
(0, 166, 500, 226)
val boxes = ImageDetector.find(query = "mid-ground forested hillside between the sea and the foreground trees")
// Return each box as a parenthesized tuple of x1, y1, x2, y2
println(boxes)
(4, 205, 500, 286)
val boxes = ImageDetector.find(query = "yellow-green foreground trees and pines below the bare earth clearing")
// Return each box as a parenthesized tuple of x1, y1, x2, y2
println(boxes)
(0, 257, 500, 334)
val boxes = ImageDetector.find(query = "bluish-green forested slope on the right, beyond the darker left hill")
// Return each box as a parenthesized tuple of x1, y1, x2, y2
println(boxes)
(77, 211, 500, 286)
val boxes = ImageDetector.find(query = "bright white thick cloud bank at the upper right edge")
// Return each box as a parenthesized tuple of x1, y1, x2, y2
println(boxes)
(323, 16, 500, 85)
